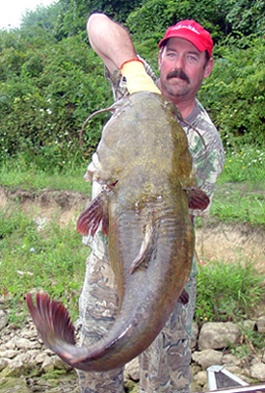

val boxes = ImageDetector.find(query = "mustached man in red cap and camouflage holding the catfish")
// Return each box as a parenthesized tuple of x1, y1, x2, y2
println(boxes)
(78, 14, 224, 393)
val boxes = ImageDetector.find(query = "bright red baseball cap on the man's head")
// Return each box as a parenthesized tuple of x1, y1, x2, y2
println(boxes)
(158, 20, 213, 56)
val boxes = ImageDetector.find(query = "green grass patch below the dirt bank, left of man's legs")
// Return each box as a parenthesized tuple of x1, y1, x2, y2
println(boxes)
(0, 206, 89, 323)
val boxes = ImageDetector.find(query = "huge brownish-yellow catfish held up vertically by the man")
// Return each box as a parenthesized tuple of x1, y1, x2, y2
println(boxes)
(27, 92, 209, 371)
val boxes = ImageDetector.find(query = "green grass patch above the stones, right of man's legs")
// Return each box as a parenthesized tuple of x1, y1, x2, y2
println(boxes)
(195, 261, 265, 322)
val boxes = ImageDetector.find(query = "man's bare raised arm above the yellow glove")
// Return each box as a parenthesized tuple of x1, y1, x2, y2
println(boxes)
(87, 13, 137, 73)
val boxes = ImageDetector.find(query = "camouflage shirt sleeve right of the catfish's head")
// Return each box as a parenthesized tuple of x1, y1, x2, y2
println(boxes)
(183, 101, 224, 216)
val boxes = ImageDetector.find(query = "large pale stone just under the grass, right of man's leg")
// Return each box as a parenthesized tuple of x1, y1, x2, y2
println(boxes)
(198, 322, 241, 350)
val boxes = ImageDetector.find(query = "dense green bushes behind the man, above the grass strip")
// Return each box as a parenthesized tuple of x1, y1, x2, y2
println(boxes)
(0, 0, 265, 171)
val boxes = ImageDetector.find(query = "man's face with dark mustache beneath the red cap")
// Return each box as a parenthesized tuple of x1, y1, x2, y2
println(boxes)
(158, 38, 213, 103)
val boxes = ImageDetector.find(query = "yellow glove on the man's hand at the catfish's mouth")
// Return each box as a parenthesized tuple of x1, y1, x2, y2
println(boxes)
(120, 58, 161, 94)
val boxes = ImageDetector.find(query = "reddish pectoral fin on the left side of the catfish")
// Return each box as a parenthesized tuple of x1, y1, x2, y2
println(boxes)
(76, 190, 109, 236)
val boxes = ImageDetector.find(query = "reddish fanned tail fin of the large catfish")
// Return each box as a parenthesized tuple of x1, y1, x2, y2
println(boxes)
(26, 293, 75, 350)
